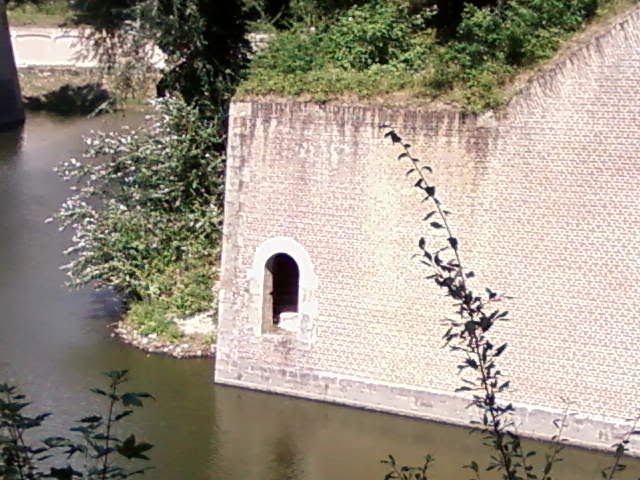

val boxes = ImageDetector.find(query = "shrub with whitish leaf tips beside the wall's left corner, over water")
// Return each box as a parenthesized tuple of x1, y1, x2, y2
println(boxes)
(56, 98, 224, 315)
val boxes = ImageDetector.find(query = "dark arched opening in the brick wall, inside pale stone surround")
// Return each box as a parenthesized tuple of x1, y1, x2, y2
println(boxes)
(262, 253, 300, 329)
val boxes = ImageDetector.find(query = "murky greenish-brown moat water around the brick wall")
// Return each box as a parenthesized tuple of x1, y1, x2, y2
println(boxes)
(0, 114, 640, 480)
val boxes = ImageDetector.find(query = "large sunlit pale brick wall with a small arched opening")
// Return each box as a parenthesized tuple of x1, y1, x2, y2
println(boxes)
(215, 8, 640, 451)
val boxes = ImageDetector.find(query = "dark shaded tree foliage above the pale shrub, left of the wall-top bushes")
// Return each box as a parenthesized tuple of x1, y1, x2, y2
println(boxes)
(67, 0, 249, 118)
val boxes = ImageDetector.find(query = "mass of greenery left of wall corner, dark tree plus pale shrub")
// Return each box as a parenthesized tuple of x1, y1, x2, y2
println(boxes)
(41, 0, 249, 344)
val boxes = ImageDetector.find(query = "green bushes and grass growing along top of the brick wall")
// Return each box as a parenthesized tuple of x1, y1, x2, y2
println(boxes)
(239, 0, 634, 112)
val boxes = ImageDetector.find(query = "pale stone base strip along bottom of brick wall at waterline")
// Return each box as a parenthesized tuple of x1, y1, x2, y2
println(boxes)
(215, 359, 640, 456)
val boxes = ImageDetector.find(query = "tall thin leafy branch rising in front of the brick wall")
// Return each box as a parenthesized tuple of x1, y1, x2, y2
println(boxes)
(383, 126, 566, 480)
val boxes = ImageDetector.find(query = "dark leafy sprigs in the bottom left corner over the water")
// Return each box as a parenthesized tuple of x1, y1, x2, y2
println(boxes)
(0, 370, 153, 480)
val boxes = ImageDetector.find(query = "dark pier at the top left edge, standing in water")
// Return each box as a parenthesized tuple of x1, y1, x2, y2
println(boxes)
(0, 0, 24, 130)
